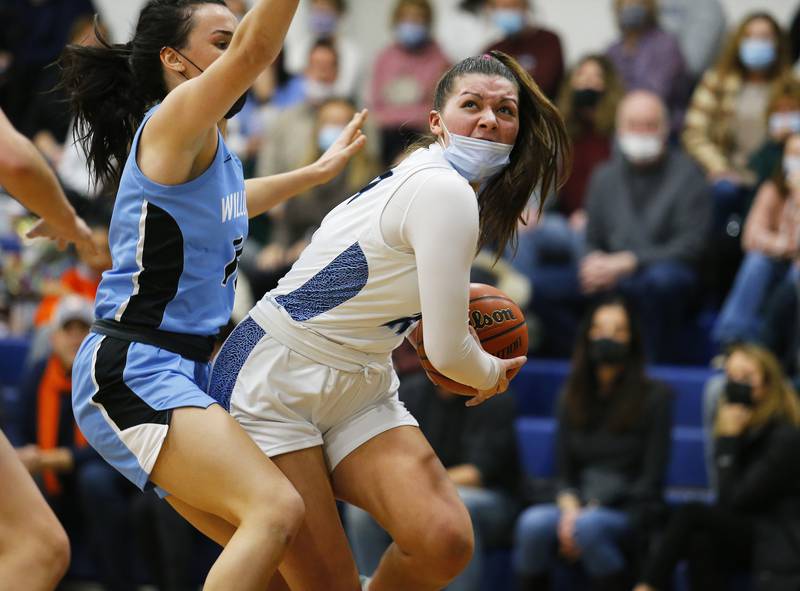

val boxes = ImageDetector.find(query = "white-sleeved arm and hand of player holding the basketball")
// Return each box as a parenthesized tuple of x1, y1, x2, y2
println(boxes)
(400, 174, 517, 402)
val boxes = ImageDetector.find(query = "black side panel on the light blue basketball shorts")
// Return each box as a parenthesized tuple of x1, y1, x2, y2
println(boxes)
(92, 337, 172, 431)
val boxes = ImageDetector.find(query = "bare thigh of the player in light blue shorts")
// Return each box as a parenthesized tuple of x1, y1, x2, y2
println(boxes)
(150, 405, 303, 529)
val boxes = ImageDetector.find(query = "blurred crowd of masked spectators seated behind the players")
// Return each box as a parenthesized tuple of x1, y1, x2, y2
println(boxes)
(0, 0, 800, 591)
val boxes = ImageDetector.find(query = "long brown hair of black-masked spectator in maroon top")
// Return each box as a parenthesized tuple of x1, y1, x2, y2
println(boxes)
(557, 53, 625, 138)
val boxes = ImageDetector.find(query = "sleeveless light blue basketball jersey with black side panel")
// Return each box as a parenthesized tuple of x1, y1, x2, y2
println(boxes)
(95, 106, 248, 336)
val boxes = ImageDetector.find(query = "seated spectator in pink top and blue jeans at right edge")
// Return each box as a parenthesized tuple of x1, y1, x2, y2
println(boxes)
(713, 133, 800, 346)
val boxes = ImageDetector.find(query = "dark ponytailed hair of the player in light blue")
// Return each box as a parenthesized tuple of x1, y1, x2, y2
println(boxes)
(59, 0, 225, 185)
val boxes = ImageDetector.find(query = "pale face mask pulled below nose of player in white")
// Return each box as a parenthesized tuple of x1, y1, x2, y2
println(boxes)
(439, 115, 514, 182)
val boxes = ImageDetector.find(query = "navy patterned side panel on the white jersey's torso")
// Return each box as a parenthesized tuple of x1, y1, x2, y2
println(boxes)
(275, 242, 369, 322)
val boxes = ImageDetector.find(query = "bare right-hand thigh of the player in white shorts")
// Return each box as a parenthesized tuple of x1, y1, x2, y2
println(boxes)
(333, 426, 472, 552)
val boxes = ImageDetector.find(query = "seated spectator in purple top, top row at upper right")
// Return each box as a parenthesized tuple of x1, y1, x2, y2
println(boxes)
(608, 0, 689, 132)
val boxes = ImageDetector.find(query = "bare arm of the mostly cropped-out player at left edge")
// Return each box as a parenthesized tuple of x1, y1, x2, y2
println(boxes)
(0, 110, 94, 249)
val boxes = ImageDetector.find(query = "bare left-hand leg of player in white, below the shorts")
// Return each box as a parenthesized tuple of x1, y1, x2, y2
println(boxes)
(273, 446, 360, 591)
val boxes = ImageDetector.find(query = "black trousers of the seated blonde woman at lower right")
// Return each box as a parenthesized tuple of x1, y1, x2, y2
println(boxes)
(642, 503, 753, 591)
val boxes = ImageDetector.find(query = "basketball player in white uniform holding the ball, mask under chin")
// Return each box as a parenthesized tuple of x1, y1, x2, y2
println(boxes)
(210, 53, 569, 591)
